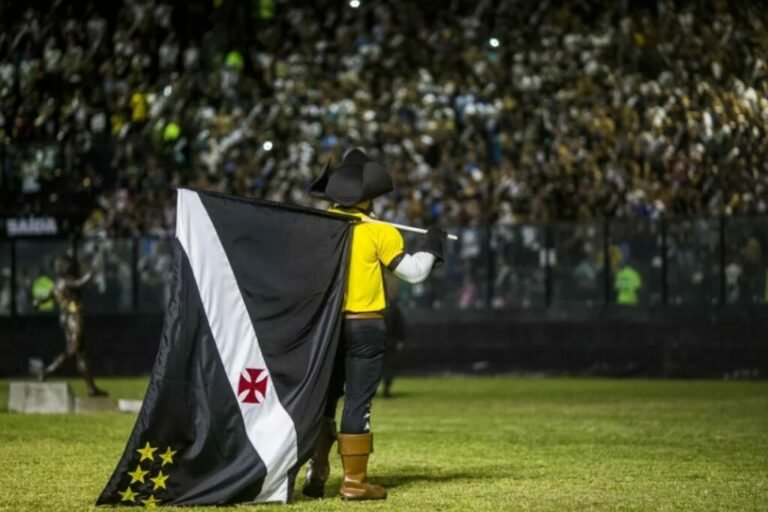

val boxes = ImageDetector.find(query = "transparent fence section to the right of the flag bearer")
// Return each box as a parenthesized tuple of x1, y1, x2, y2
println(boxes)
(397, 217, 768, 309)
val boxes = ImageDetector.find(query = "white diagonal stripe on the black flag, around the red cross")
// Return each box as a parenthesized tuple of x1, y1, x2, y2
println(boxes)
(176, 190, 297, 502)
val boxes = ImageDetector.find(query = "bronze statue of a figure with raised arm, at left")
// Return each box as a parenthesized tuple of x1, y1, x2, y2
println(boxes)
(34, 256, 107, 396)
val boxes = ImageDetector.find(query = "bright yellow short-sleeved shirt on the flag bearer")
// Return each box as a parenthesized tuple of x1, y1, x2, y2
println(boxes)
(330, 207, 405, 313)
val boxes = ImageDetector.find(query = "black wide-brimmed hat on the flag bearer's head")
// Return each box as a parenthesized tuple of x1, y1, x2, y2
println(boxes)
(309, 149, 394, 206)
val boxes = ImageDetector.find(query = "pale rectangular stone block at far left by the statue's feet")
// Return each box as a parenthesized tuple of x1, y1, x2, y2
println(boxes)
(8, 381, 75, 414)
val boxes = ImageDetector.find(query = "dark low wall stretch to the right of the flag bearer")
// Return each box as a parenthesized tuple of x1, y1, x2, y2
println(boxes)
(399, 307, 768, 378)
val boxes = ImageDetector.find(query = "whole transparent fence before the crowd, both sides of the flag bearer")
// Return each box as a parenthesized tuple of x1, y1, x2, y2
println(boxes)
(0, 217, 768, 316)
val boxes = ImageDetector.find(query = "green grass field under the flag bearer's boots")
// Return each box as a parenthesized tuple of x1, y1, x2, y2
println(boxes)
(0, 378, 768, 512)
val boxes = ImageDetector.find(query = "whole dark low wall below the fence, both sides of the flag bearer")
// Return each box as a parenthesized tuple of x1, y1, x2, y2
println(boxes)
(0, 307, 768, 378)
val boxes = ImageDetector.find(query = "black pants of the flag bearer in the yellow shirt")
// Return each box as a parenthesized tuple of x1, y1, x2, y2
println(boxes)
(325, 318, 387, 434)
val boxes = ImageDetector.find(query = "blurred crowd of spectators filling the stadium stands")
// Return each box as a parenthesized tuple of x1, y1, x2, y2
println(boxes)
(0, 0, 768, 307)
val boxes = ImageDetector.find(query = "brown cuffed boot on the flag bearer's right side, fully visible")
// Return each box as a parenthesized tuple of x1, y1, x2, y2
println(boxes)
(339, 433, 387, 500)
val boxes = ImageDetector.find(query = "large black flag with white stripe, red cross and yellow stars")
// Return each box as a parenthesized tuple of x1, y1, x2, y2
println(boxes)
(97, 189, 351, 506)
